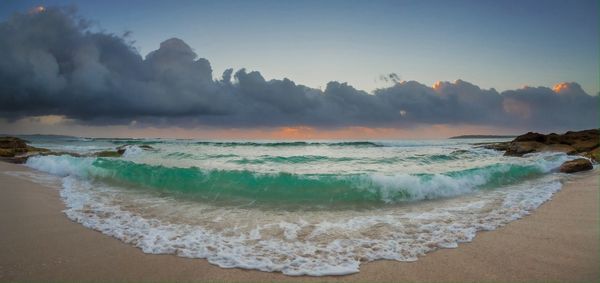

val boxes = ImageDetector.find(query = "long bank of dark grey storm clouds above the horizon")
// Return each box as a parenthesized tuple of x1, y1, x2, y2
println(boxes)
(0, 8, 600, 129)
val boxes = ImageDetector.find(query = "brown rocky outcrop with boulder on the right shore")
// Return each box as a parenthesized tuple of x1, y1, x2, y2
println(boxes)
(482, 129, 600, 173)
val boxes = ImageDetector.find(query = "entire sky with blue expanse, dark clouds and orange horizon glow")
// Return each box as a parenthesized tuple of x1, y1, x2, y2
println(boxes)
(0, 0, 600, 138)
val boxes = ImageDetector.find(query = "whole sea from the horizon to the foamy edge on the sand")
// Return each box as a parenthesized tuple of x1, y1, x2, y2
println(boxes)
(13, 136, 574, 276)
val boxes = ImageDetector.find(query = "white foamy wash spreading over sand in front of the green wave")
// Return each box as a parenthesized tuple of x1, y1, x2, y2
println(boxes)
(51, 174, 561, 276)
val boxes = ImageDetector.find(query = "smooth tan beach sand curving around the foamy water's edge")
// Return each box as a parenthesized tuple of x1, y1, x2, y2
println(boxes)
(0, 162, 600, 282)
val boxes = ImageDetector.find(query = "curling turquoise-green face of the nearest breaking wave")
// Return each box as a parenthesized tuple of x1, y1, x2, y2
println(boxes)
(54, 158, 543, 204)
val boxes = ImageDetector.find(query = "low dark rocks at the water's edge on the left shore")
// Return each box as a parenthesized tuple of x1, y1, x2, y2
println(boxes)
(0, 137, 153, 164)
